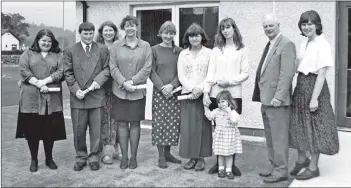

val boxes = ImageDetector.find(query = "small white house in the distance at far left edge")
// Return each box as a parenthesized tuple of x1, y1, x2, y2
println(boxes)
(1, 29, 20, 51)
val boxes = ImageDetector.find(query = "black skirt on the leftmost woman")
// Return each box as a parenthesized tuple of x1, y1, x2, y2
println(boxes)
(16, 108, 66, 141)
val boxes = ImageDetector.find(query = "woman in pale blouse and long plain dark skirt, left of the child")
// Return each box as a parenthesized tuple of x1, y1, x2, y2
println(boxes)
(177, 23, 212, 171)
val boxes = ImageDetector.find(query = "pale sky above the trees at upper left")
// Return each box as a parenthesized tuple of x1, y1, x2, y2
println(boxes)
(1, 1, 76, 31)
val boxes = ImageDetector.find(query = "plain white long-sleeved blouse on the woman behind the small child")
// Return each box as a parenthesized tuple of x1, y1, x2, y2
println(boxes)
(204, 47, 249, 98)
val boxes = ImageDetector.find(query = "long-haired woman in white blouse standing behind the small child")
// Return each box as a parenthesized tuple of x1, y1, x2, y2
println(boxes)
(203, 18, 249, 176)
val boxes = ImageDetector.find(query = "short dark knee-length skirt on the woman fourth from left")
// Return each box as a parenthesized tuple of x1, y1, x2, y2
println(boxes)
(111, 95, 146, 122)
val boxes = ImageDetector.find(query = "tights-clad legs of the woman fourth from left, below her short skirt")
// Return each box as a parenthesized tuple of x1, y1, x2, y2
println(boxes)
(117, 121, 140, 159)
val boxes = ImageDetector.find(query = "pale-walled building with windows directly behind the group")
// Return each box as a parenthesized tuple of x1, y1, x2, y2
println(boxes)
(76, 0, 351, 130)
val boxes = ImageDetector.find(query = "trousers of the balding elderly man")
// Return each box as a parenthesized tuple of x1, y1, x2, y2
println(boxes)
(261, 105, 291, 177)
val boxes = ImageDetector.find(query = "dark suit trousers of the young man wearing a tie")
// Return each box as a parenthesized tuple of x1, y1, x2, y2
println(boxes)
(71, 107, 103, 162)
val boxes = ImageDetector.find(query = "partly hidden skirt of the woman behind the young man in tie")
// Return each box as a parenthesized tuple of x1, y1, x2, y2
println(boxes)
(101, 79, 118, 145)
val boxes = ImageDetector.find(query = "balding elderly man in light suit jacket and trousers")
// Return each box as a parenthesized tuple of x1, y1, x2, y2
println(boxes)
(252, 14, 296, 183)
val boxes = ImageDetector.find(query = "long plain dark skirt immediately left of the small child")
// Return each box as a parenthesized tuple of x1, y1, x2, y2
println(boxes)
(179, 96, 212, 158)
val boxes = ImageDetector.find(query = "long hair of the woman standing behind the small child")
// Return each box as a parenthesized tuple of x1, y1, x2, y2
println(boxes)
(215, 17, 244, 50)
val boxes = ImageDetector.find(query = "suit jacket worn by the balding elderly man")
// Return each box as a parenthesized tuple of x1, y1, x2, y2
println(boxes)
(252, 35, 296, 106)
